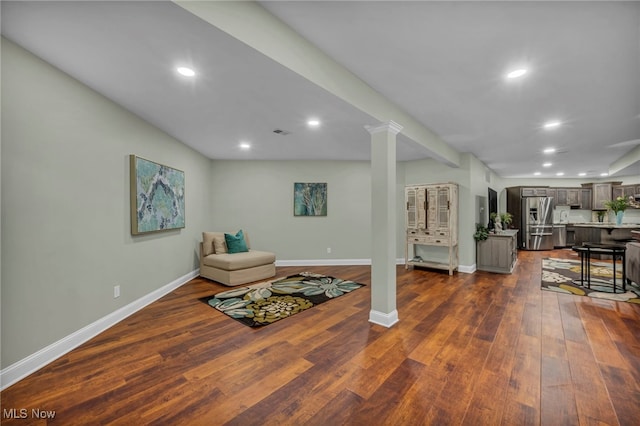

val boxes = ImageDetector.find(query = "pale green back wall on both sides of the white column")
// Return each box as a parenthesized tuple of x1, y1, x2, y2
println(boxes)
(211, 154, 500, 266)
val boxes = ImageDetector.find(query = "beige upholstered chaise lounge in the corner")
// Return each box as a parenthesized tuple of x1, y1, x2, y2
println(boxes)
(200, 232, 276, 286)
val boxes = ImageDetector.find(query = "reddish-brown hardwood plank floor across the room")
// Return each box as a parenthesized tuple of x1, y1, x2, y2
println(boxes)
(0, 250, 640, 426)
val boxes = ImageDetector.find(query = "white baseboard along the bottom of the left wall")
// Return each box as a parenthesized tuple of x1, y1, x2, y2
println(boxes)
(0, 269, 200, 390)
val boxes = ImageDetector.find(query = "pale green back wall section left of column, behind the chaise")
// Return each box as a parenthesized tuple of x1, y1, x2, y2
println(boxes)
(209, 161, 380, 260)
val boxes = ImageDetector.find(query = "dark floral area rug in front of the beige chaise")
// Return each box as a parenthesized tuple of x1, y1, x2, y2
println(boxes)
(200, 272, 364, 327)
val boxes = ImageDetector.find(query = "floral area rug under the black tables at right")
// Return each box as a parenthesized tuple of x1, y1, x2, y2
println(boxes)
(542, 258, 640, 304)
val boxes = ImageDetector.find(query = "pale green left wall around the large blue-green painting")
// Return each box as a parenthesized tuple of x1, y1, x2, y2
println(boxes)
(1, 39, 212, 368)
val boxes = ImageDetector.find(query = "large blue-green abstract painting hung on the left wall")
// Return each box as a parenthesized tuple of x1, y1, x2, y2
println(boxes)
(129, 155, 185, 235)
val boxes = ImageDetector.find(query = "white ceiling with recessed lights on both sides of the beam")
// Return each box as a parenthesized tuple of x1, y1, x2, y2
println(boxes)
(1, 1, 640, 178)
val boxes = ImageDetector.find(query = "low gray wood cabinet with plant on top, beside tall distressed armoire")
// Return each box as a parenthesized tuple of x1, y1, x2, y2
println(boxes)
(476, 229, 518, 274)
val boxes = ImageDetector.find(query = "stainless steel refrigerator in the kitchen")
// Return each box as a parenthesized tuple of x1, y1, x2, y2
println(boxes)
(520, 197, 553, 250)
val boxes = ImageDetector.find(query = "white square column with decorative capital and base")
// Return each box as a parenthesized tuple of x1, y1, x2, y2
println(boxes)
(365, 121, 402, 327)
